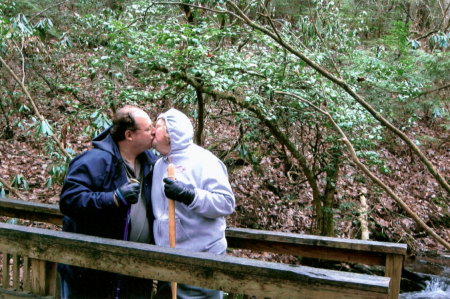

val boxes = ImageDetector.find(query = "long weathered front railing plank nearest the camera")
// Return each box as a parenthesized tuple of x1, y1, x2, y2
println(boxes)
(0, 223, 390, 298)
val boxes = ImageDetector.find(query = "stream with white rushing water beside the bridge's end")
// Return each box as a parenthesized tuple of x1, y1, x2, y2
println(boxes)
(400, 255, 450, 299)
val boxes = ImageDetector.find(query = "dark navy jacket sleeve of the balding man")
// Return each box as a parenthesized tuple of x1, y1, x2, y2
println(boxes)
(60, 149, 117, 217)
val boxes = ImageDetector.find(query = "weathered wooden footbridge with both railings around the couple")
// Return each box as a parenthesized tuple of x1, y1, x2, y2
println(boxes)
(0, 200, 406, 299)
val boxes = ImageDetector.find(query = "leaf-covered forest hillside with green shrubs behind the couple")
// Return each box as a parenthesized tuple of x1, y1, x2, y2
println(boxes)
(0, 0, 450, 259)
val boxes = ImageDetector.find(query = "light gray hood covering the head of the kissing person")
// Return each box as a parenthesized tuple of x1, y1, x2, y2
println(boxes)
(158, 108, 194, 153)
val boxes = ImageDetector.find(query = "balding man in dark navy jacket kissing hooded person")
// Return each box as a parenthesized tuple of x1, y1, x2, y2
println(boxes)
(58, 106, 156, 298)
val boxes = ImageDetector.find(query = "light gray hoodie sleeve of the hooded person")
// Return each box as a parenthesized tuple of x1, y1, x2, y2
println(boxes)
(188, 159, 236, 218)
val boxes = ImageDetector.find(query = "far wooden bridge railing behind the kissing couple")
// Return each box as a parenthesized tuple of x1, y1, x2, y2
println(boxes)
(0, 200, 406, 298)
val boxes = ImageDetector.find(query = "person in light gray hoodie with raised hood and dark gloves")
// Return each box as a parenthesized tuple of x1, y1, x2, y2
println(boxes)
(151, 108, 235, 298)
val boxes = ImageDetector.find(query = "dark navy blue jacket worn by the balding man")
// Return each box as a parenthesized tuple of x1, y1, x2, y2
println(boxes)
(59, 129, 157, 298)
